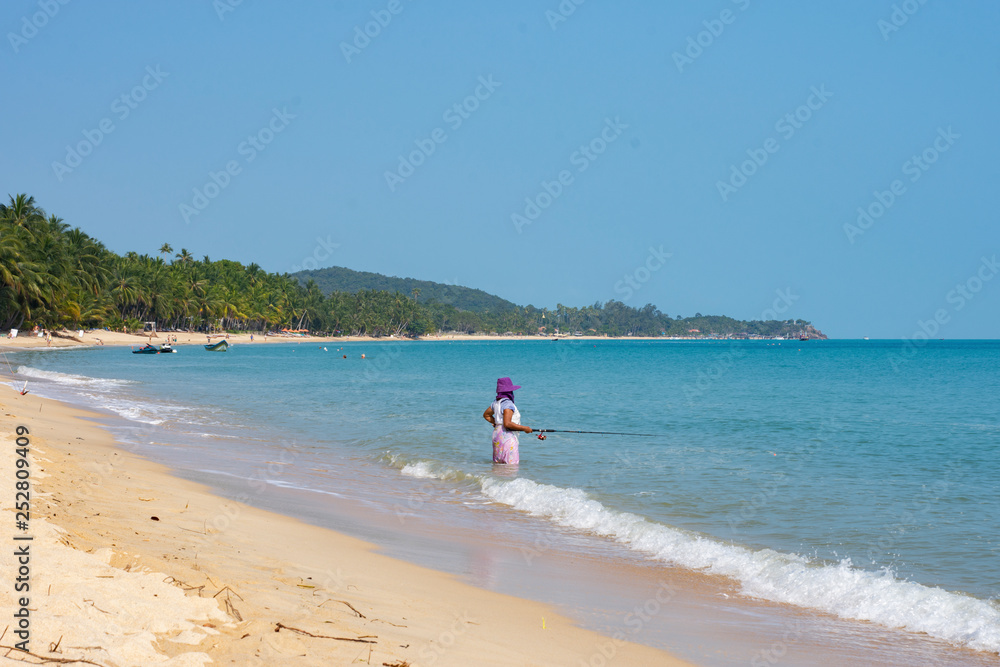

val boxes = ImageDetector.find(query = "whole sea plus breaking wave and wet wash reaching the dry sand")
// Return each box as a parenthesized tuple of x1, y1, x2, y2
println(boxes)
(4, 336, 1000, 665)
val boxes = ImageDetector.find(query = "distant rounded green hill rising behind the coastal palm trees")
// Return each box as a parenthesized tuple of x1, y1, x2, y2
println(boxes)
(291, 266, 517, 313)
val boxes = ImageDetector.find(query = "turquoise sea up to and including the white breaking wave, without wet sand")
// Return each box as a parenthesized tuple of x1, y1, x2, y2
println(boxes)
(11, 340, 1000, 654)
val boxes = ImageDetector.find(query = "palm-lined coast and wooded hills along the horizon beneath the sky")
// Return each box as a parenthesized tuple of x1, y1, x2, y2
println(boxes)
(0, 194, 826, 339)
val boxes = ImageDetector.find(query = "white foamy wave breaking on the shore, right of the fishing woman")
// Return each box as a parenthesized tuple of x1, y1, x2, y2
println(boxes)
(401, 461, 1000, 653)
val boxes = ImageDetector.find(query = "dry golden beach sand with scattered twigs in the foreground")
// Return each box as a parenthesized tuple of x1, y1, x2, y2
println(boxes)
(0, 388, 688, 667)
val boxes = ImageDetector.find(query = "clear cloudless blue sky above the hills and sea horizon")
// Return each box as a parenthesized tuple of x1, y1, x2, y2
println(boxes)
(0, 0, 1000, 338)
